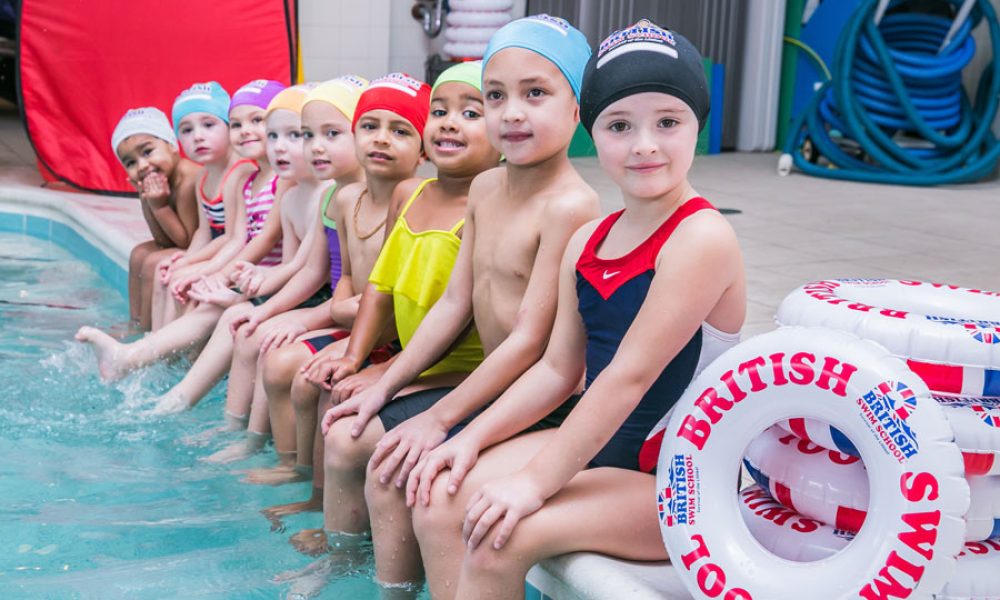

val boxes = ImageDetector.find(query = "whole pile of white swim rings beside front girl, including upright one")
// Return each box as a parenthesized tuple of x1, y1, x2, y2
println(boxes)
(650, 279, 1000, 600)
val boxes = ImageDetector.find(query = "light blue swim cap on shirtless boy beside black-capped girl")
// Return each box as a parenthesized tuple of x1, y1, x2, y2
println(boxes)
(483, 14, 590, 102)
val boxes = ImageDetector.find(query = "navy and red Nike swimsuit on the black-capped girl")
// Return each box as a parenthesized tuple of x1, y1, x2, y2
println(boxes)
(576, 198, 715, 471)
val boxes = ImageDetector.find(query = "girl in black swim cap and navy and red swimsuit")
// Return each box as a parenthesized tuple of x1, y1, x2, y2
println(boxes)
(410, 21, 746, 599)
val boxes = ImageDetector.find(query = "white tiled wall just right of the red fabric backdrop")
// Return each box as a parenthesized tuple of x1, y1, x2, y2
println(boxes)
(299, 0, 527, 81)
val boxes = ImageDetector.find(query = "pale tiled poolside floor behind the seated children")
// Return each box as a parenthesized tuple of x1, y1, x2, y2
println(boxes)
(0, 107, 1000, 335)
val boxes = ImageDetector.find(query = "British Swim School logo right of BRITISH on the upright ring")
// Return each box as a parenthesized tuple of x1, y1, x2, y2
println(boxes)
(857, 381, 919, 464)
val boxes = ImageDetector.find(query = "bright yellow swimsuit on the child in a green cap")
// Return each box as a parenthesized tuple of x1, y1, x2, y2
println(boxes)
(368, 179, 483, 377)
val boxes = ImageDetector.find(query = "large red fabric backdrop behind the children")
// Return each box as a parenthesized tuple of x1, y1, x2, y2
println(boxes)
(18, 0, 295, 193)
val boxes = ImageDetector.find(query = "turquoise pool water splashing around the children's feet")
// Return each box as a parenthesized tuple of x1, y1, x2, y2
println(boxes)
(0, 234, 390, 599)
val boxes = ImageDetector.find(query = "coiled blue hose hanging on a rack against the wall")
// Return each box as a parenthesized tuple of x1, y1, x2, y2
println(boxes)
(783, 0, 1000, 186)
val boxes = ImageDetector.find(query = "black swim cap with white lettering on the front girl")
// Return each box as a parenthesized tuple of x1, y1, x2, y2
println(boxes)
(580, 19, 710, 133)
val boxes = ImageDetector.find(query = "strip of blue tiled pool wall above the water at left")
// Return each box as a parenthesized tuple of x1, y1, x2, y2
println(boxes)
(0, 205, 128, 299)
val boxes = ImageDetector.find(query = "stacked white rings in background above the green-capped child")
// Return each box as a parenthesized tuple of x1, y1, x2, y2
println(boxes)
(443, 0, 514, 60)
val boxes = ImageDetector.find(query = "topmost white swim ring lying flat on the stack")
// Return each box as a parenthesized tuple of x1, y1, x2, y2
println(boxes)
(776, 279, 1000, 397)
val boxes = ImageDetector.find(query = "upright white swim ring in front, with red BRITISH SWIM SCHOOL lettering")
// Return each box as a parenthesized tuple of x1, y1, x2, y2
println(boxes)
(651, 327, 969, 600)
